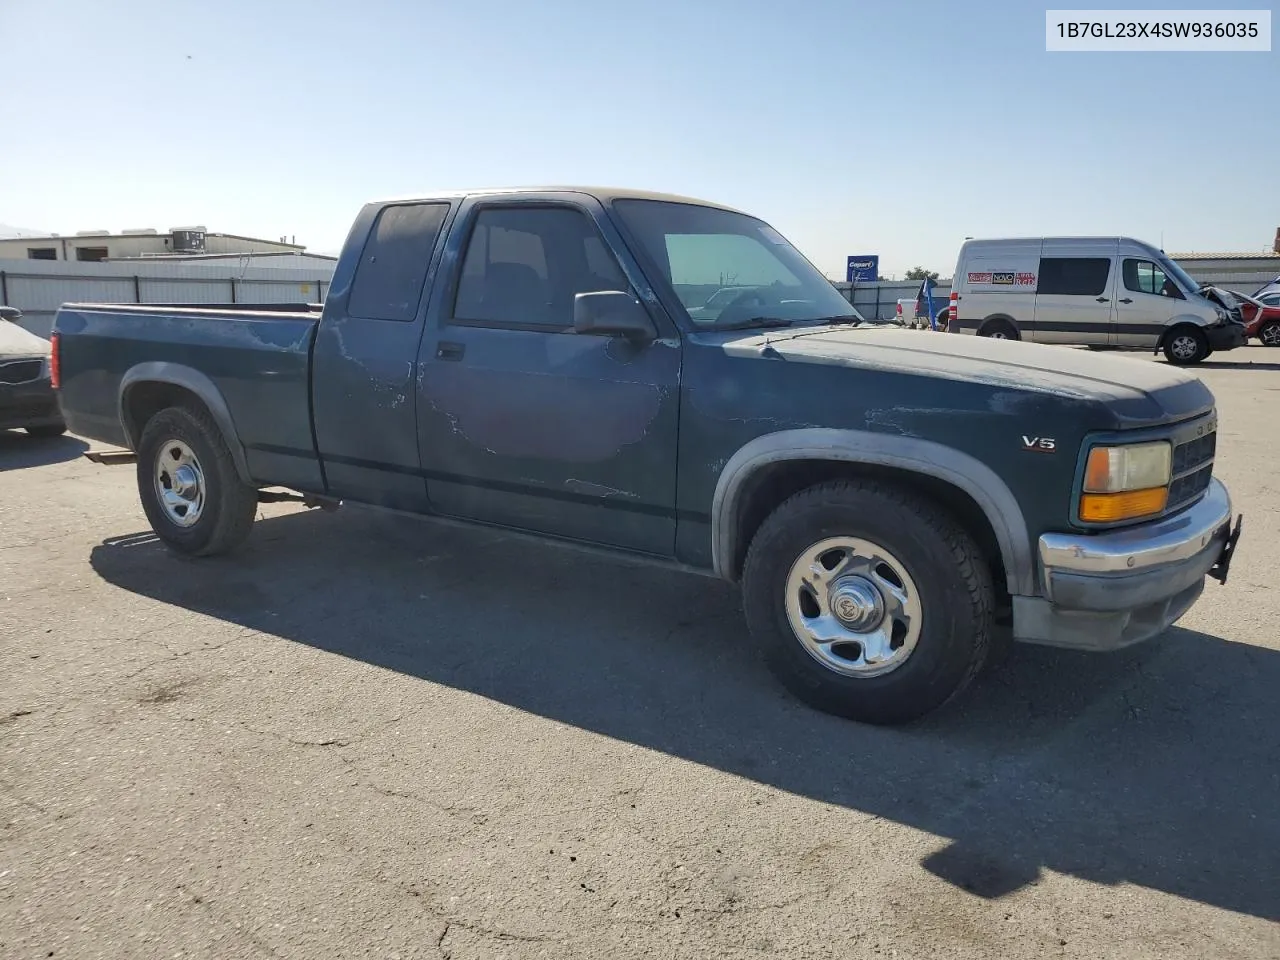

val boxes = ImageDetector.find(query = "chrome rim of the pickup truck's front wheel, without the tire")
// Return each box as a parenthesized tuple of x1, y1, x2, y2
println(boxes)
(786, 536, 923, 677)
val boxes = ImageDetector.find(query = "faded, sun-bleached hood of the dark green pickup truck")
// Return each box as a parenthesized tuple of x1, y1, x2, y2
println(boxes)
(716, 326, 1213, 429)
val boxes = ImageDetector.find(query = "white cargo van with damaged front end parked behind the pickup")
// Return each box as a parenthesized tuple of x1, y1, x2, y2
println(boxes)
(947, 237, 1245, 365)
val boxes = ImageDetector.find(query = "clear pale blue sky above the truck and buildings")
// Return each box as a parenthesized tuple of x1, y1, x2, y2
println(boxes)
(0, 0, 1280, 276)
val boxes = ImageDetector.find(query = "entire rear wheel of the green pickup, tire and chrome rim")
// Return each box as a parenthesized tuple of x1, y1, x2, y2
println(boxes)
(137, 407, 257, 557)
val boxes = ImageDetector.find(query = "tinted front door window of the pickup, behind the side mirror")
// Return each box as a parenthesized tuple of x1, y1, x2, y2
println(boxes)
(453, 206, 630, 332)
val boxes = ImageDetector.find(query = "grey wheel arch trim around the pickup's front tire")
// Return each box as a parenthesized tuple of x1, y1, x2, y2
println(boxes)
(712, 428, 1038, 595)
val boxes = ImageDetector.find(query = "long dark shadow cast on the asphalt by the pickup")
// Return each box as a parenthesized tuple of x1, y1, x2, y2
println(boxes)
(91, 509, 1280, 920)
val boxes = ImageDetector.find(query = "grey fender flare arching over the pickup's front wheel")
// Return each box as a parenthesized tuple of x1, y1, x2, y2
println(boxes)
(712, 428, 1039, 596)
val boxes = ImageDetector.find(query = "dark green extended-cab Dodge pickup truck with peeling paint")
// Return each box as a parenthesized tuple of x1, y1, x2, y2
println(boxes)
(52, 187, 1239, 723)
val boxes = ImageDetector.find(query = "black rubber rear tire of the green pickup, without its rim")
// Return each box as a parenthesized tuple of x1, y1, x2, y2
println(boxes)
(137, 407, 257, 557)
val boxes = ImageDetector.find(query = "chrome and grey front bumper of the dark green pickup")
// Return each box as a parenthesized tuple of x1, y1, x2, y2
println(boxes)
(1014, 479, 1239, 650)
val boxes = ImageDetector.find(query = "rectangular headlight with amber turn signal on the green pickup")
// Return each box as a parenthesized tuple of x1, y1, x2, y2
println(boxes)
(1080, 440, 1172, 524)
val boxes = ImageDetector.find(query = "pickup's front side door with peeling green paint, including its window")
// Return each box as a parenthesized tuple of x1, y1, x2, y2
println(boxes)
(419, 195, 680, 557)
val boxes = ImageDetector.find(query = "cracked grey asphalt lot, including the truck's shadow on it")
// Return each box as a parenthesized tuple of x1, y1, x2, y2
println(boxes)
(0, 347, 1280, 960)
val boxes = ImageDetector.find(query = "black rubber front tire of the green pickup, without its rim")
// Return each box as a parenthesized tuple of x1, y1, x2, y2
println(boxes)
(742, 480, 995, 724)
